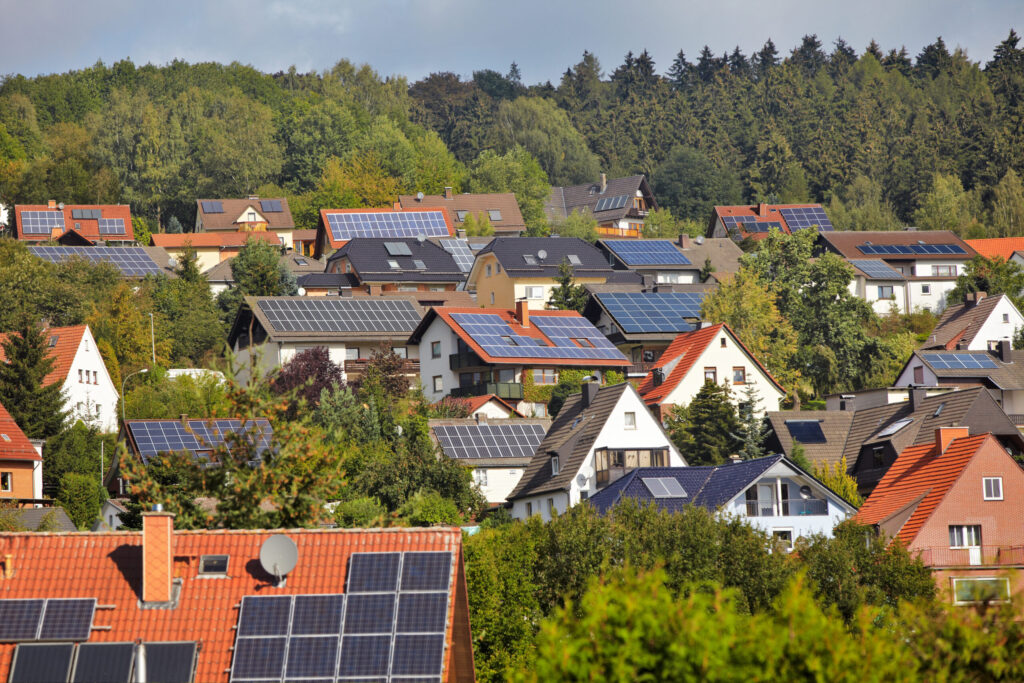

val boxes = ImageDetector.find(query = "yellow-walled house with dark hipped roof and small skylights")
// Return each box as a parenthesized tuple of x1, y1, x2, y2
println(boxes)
(466, 238, 626, 310)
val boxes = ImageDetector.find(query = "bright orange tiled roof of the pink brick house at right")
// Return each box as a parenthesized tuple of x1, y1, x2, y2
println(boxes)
(856, 432, 1001, 545)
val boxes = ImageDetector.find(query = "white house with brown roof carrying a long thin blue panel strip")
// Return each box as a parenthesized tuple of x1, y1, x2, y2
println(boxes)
(818, 229, 976, 313)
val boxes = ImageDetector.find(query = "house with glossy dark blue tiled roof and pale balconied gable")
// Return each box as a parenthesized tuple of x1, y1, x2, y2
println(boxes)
(590, 455, 857, 550)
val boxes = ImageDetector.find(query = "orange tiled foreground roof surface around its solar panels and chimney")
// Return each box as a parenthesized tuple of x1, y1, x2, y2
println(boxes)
(0, 527, 473, 683)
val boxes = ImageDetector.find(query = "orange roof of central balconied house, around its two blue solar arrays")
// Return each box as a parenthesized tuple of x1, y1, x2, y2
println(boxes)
(409, 306, 630, 368)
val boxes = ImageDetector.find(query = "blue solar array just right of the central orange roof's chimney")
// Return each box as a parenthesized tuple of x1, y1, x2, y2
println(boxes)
(594, 292, 706, 334)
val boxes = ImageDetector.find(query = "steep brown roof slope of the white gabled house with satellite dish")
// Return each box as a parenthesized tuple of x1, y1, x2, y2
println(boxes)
(508, 382, 636, 501)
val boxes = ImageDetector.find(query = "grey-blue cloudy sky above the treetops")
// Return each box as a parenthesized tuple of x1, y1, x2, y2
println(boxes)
(0, 0, 1024, 84)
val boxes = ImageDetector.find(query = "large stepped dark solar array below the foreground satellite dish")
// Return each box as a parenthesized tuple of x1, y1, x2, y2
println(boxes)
(230, 552, 453, 683)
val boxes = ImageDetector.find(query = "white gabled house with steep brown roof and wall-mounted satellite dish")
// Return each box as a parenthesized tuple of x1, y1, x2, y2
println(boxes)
(508, 382, 686, 521)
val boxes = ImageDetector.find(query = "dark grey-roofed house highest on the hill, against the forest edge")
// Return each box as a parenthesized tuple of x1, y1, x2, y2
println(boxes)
(544, 173, 657, 239)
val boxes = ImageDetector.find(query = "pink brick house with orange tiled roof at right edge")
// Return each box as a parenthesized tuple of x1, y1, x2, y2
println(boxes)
(856, 427, 1024, 604)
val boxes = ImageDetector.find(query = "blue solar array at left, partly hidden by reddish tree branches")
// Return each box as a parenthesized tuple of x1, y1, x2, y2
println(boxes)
(127, 418, 273, 464)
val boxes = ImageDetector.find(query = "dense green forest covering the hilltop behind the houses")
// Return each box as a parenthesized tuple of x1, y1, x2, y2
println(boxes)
(0, 30, 1024, 236)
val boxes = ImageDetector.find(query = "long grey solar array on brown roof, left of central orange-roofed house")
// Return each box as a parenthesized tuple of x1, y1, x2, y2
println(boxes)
(256, 297, 421, 334)
